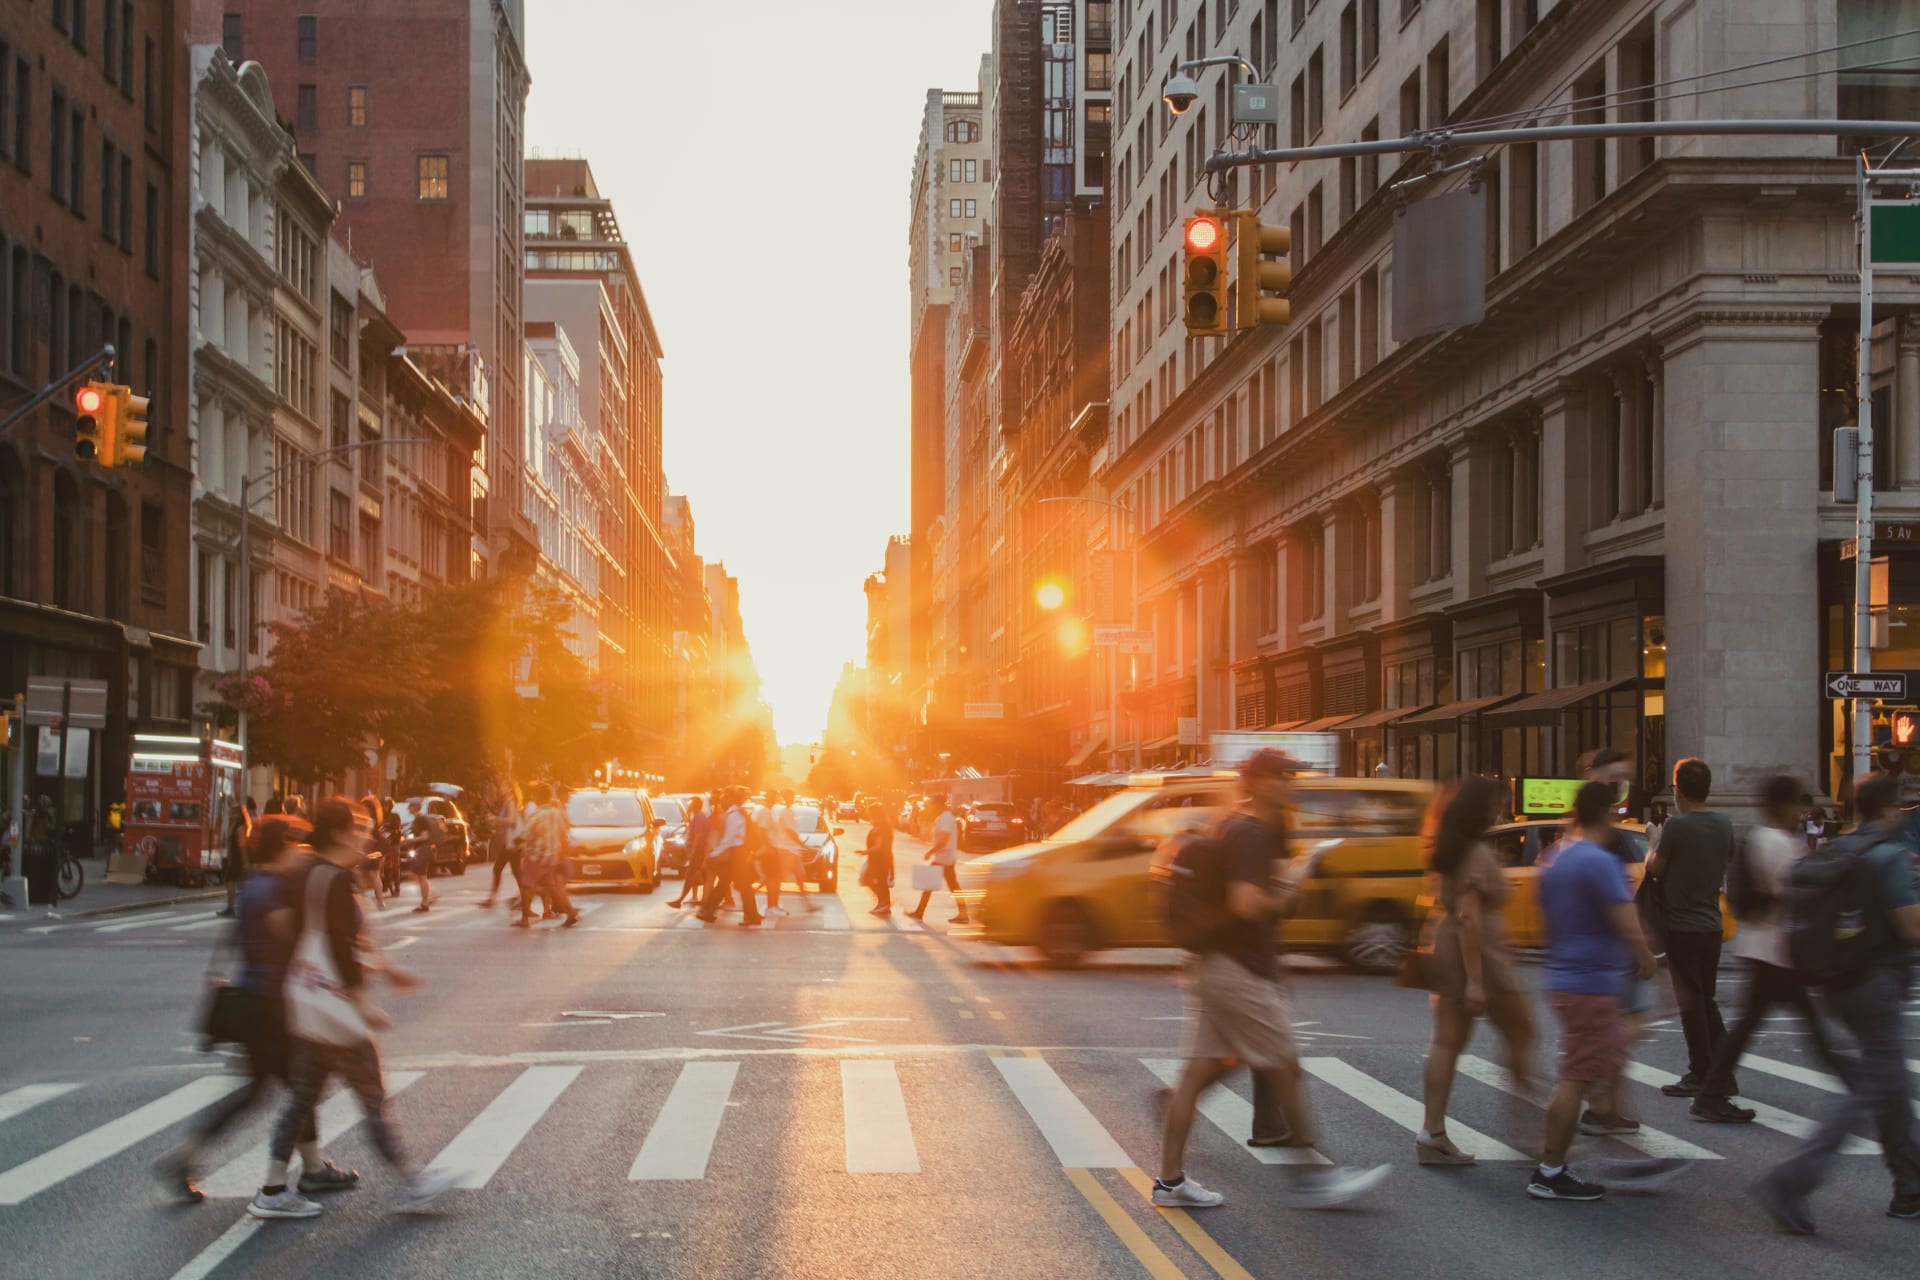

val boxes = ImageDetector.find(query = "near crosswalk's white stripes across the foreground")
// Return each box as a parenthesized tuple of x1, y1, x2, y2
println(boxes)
(0, 1052, 1920, 1222)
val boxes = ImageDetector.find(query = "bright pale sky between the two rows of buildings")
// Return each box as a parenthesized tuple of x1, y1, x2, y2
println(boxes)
(526, 0, 993, 743)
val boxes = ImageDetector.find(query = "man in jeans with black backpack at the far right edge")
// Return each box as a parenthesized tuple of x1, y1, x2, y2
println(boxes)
(1753, 775, 1920, 1236)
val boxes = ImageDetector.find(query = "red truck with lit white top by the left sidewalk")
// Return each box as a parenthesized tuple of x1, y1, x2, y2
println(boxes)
(125, 733, 240, 889)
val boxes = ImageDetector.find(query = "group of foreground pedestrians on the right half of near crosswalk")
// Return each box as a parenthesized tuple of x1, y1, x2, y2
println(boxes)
(1152, 750, 1920, 1234)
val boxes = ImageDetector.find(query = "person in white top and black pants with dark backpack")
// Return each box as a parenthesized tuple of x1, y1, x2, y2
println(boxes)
(1688, 775, 1843, 1125)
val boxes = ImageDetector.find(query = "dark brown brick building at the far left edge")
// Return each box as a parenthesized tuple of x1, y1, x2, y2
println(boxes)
(0, 0, 196, 829)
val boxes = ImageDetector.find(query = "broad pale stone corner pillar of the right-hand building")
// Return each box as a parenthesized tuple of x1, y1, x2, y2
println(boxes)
(1665, 311, 1826, 808)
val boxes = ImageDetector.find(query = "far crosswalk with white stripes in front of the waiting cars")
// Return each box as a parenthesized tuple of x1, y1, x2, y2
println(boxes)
(13, 881, 975, 942)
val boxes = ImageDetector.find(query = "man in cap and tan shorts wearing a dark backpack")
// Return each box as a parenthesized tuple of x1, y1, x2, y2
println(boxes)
(1154, 748, 1388, 1209)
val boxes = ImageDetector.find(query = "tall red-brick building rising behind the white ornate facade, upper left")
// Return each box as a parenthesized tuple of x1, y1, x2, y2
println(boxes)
(205, 0, 538, 564)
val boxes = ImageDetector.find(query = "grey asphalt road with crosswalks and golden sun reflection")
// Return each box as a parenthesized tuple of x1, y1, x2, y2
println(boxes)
(0, 829, 1920, 1280)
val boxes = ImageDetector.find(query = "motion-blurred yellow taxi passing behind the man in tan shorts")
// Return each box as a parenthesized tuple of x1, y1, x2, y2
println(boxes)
(956, 773, 1434, 973)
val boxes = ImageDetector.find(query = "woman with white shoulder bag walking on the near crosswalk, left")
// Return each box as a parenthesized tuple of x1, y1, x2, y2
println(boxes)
(248, 796, 457, 1219)
